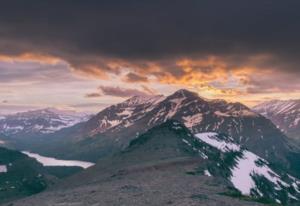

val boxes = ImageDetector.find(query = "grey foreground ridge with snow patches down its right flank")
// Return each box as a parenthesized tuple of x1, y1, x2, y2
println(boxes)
(7, 120, 300, 206)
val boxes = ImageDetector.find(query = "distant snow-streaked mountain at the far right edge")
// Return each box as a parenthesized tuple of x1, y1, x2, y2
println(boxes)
(253, 99, 300, 141)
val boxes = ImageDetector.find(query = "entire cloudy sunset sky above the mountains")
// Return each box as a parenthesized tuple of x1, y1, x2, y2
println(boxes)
(0, 0, 300, 114)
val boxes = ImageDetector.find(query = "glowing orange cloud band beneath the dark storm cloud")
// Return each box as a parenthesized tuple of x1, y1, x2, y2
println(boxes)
(0, 50, 300, 105)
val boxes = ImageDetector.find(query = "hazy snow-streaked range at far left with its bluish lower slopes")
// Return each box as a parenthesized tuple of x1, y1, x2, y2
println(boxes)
(0, 108, 91, 150)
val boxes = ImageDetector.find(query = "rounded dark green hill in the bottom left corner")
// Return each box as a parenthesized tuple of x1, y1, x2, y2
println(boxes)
(0, 147, 49, 203)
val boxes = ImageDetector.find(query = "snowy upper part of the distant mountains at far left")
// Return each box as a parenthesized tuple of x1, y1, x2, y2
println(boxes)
(0, 108, 89, 138)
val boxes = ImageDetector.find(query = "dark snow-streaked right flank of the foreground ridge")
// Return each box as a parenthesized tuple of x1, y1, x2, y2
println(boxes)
(195, 133, 300, 205)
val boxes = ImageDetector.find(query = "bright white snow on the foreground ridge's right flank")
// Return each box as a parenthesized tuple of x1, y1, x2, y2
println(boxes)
(195, 132, 299, 199)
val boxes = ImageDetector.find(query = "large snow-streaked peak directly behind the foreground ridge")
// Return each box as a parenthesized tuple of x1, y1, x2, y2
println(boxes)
(17, 90, 298, 175)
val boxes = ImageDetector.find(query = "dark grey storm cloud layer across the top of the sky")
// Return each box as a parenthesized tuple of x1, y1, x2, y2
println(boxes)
(0, 0, 300, 73)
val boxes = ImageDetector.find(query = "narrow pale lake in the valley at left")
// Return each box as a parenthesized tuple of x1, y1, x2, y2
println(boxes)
(22, 151, 94, 169)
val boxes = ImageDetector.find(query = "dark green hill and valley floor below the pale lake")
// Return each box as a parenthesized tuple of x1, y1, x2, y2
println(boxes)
(0, 147, 82, 203)
